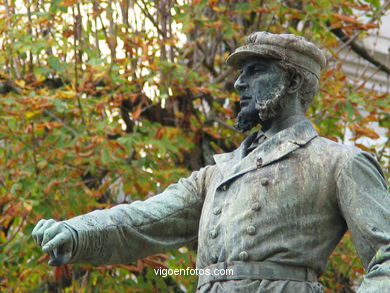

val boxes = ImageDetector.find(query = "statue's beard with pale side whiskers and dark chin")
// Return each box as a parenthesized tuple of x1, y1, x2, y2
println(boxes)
(234, 85, 287, 132)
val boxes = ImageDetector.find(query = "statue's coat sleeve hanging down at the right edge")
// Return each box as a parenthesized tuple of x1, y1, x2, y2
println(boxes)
(337, 152, 390, 293)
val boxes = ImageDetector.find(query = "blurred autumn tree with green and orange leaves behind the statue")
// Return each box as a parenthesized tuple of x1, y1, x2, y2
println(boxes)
(0, 0, 390, 292)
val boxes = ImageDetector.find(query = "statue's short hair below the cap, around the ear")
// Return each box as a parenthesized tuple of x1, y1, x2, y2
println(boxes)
(278, 61, 320, 111)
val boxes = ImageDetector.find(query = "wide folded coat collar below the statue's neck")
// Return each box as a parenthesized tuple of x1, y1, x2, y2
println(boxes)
(214, 119, 318, 182)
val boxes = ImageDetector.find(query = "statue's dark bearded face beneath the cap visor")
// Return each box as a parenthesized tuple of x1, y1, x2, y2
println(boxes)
(234, 58, 286, 132)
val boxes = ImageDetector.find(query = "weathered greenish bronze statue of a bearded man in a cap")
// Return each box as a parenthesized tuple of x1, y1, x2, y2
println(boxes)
(32, 32, 390, 293)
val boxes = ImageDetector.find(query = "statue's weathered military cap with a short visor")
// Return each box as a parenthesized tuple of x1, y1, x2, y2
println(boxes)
(226, 32, 326, 78)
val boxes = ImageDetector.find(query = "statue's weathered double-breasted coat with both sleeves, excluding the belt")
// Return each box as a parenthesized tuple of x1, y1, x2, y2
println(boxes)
(64, 120, 390, 293)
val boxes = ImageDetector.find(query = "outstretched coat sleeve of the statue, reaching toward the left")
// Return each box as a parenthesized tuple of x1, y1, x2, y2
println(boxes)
(63, 166, 213, 265)
